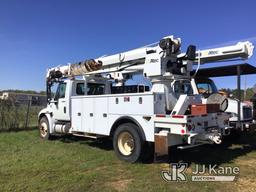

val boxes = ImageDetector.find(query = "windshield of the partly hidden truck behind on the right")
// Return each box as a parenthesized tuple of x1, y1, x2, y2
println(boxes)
(196, 79, 218, 96)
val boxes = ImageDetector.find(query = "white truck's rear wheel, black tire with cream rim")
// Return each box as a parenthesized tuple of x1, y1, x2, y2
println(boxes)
(113, 123, 144, 163)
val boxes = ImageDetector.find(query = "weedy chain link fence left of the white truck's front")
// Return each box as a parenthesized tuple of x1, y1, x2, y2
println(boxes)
(0, 97, 45, 132)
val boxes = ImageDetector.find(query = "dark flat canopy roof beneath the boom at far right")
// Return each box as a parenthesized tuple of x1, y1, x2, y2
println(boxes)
(192, 63, 256, 77)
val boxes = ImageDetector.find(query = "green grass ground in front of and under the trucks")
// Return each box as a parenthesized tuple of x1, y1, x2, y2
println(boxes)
(0, 130, 256, 192)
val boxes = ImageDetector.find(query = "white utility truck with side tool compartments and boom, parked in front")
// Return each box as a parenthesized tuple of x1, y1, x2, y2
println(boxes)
(39, 36, 252, 162)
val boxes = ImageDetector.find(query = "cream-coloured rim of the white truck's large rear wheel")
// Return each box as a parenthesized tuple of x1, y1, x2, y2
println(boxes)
(118, 132, 134, 156)
